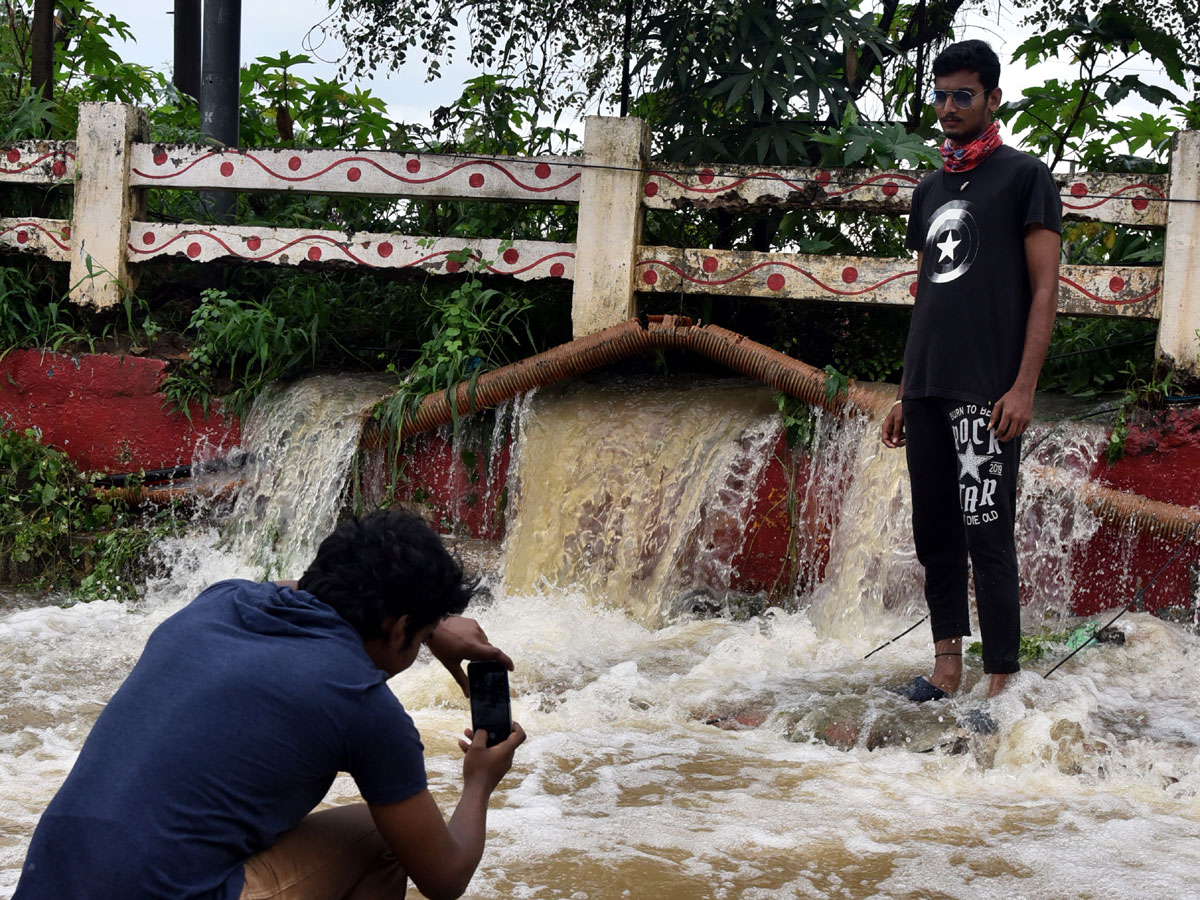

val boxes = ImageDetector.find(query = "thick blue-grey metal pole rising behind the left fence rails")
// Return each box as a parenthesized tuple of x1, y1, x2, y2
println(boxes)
(200, 0, 241, 222)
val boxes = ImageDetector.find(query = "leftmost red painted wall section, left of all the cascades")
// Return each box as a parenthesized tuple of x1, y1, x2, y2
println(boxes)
(0, 350, 241, 473)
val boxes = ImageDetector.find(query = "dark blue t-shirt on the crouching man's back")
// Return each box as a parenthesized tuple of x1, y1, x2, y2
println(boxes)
(13, 581, 426, 900)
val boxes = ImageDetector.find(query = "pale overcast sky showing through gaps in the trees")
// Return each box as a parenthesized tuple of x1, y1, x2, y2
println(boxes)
(96, 0, 1164, 140)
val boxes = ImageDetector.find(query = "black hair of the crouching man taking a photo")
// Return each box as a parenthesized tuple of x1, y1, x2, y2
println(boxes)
(300, 510, 479, 641)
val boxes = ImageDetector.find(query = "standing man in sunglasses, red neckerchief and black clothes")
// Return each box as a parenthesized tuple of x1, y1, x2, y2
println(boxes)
(882, 41, 1062, 702)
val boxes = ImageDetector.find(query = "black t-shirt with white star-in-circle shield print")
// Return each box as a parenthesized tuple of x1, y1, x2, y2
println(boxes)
(904, 146, 1062, 403)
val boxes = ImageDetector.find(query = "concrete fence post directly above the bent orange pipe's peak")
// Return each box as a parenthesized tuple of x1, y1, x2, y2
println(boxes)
(571, 115, 649, 337)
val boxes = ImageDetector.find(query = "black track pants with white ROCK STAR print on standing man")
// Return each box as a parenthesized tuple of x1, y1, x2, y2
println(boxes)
(904, 397, 1021, 674)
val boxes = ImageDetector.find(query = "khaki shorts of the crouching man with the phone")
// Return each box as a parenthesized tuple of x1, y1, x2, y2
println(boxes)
(241, 803, 408, 900)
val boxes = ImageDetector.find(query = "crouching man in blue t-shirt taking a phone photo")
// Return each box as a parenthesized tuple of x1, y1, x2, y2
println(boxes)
(13, 511, 524, 900)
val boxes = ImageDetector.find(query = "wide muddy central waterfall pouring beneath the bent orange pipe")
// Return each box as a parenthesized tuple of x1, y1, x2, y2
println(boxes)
(496, 382, 779, 624)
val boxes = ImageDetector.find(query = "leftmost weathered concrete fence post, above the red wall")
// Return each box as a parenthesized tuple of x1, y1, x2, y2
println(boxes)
(71, 103, 149, 310)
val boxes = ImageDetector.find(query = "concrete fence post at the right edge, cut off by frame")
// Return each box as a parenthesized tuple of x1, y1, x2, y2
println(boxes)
(1158, 131, 1200, 378)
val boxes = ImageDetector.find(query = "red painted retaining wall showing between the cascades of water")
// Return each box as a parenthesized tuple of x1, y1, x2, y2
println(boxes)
(0, 350, 1200, 613)
